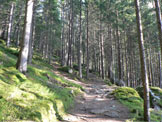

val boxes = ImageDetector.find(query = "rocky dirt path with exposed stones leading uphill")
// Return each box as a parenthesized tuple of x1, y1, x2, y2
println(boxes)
(55, 63, 130, 122)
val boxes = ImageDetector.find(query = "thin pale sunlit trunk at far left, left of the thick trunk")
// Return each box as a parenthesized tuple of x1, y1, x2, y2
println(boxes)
(7, 2, 15, 47)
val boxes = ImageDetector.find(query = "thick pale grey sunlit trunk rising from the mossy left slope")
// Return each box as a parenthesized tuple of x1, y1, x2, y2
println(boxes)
(17, 0, 34, 73)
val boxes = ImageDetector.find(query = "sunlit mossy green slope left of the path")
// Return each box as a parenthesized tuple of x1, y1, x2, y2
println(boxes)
(0, 40, 81, 122)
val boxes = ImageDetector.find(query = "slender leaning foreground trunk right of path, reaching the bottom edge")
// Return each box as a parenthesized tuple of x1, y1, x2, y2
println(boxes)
(134, 0, 150, 122)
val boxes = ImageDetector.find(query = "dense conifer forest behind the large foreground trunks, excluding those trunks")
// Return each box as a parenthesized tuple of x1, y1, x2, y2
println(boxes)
(0, 0, 161, 87)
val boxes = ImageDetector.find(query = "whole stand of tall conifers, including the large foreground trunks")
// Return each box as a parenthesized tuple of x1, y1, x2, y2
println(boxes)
(0, 0, 162, 121)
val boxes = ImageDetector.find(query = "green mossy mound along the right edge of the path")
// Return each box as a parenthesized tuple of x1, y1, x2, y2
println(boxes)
(113, 87, 162, 122)
